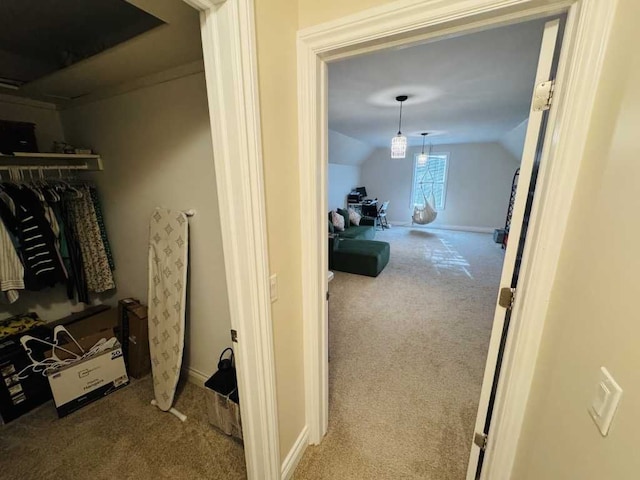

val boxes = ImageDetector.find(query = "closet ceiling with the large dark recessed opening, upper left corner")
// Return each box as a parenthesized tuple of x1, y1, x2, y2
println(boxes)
(0, 0, 202, 105)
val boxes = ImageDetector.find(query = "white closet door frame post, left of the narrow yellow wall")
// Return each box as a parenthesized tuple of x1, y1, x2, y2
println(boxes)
(184, 0, 281, 480)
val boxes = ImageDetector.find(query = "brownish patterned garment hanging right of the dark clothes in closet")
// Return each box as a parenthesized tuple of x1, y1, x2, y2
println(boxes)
(69, 185, 116, 293)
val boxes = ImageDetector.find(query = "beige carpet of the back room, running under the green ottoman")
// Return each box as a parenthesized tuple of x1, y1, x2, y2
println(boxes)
(294, 227, 503, 480)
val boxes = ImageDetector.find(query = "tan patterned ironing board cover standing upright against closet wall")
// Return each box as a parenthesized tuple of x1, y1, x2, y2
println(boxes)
(149, 208, 189, 411)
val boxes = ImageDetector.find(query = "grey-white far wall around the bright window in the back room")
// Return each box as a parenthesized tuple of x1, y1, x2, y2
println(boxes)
(361, 143, 518, 230)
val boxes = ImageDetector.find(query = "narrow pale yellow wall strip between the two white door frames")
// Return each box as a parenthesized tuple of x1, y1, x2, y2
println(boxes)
(256, 0, 305, 459)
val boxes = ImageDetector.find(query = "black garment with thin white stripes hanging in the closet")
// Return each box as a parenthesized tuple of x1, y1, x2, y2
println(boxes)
(3, 183, 67, 290)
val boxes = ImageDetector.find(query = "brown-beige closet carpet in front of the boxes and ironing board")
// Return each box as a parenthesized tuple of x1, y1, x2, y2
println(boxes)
(0, 377, 246, 480)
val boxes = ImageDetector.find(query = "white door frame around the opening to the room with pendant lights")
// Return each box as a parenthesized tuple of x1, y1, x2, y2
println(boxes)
(298, 0, 617, 480)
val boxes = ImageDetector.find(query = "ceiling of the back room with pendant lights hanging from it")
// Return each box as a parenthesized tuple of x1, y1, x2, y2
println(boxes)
(329, 19, 545, 147)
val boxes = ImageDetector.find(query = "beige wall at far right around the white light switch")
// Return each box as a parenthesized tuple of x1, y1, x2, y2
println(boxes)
(513, 0, 640, 480)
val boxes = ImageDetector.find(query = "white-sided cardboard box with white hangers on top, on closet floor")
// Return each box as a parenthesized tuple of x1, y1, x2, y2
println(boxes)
(47, 329, 129, 417)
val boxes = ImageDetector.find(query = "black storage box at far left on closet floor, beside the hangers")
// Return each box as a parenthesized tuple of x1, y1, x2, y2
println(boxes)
(0, 317, 51, 423)
